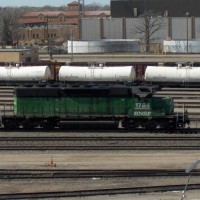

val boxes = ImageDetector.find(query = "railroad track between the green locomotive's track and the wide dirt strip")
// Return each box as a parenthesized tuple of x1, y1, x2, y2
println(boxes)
(0, 136, 200, 151)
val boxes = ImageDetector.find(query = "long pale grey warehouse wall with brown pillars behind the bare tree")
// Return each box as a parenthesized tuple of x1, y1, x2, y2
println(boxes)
(80, 17, 200, 53)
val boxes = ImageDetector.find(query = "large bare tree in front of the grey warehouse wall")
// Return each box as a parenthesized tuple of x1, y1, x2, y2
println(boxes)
(133, 10, 166, 52)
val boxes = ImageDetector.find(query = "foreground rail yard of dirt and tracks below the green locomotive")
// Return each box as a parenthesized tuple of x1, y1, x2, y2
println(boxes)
(0, 131, 200, 200)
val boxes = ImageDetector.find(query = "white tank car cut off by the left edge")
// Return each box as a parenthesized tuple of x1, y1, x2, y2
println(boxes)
(0, 66, 51, 82)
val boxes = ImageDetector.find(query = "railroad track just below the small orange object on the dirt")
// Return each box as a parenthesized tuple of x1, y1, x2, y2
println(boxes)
(0, 169, 200, 180)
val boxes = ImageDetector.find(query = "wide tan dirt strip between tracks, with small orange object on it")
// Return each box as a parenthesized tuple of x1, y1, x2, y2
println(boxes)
(0, 151, 200, 169)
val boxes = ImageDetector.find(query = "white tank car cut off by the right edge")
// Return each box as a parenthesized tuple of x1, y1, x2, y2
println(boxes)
(144, 66, 200, 83)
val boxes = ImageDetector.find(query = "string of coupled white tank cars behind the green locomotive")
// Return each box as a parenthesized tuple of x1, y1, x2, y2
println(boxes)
(0, 63, 200, 87)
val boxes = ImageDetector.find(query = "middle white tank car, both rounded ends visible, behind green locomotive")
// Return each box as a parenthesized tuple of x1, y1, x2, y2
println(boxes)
(59, 66, 136, 82)
